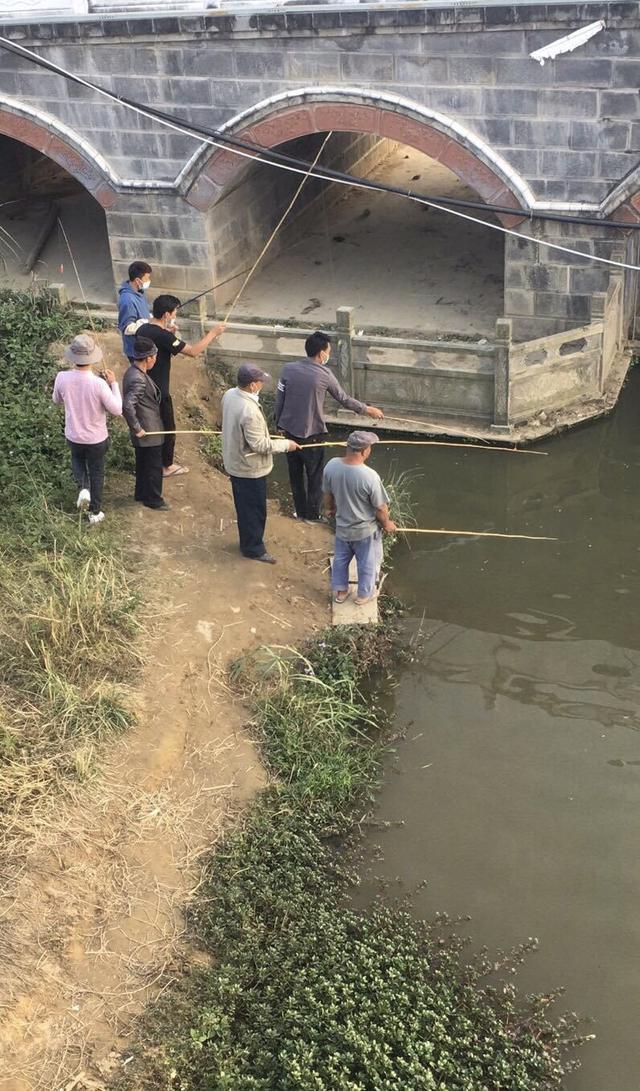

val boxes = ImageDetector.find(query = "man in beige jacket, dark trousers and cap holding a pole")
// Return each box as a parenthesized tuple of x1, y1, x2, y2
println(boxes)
(222, 363, 298, 564)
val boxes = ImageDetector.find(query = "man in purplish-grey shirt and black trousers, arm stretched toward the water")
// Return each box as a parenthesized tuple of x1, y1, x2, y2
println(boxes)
(275, 331, 384, 523)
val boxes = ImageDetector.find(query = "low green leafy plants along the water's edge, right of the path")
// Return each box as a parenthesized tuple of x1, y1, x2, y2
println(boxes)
(117, 625, 577, 1091)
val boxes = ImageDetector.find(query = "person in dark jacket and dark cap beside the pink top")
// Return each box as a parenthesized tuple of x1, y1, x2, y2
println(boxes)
(122, 337, 169, 512)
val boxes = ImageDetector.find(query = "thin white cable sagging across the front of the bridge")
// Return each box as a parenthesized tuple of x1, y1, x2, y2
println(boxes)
(0, 36, 640, 271)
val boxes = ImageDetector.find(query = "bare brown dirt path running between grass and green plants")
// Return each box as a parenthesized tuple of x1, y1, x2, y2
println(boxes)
(0, 344, 329, 1091)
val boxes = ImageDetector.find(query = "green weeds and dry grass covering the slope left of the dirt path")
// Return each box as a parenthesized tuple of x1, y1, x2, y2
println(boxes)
(0, 291, 140, 833)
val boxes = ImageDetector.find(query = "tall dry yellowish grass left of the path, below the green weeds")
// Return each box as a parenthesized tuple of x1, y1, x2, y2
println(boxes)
(0, 499, 141, 844)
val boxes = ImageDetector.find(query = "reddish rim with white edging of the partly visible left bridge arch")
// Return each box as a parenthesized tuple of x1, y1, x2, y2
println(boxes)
(0, 95, 118, 208)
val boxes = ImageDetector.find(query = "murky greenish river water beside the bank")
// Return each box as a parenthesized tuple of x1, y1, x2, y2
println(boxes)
(358, 371, 640, 1091)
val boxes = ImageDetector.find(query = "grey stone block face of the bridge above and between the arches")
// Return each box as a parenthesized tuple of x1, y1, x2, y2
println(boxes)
(0, 3, 640, 339)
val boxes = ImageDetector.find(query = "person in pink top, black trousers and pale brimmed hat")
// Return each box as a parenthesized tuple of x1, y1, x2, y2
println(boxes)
(53, 334, 122, 524)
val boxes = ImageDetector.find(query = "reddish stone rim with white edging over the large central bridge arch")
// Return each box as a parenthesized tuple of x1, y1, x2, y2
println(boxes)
(183, 87, 535, 226)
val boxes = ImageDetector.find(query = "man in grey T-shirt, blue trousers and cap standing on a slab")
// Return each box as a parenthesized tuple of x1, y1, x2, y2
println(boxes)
(323, 431, 397, 607)
